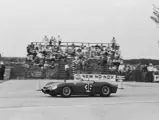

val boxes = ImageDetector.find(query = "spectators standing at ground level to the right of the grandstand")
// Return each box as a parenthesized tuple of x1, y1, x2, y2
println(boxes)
(119, 63, 159, 82)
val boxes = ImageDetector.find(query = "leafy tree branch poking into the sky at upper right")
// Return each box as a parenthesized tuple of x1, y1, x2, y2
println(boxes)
(150, 5, 159, 24)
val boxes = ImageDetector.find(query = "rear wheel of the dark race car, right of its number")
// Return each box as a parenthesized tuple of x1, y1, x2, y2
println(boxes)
(100, 85, 111, 97)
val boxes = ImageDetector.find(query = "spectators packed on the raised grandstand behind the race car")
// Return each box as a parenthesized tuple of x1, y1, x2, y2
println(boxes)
(26, 35, 122, 69)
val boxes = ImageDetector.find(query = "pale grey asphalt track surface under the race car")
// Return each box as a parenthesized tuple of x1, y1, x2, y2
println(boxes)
(0, 80, 159, 120)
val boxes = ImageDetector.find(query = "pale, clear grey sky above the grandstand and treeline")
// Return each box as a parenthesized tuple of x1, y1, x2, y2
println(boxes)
(0, 0, 159, 59)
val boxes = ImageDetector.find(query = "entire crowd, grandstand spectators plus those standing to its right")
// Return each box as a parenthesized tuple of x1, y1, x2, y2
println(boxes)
(26, 35, 159, 82)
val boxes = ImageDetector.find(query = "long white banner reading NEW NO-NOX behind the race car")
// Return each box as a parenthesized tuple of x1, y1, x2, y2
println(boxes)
(74, 74, 116, 81)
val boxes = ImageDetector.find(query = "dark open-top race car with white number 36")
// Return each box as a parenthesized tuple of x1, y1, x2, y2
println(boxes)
(41, 80, 118, 97)
